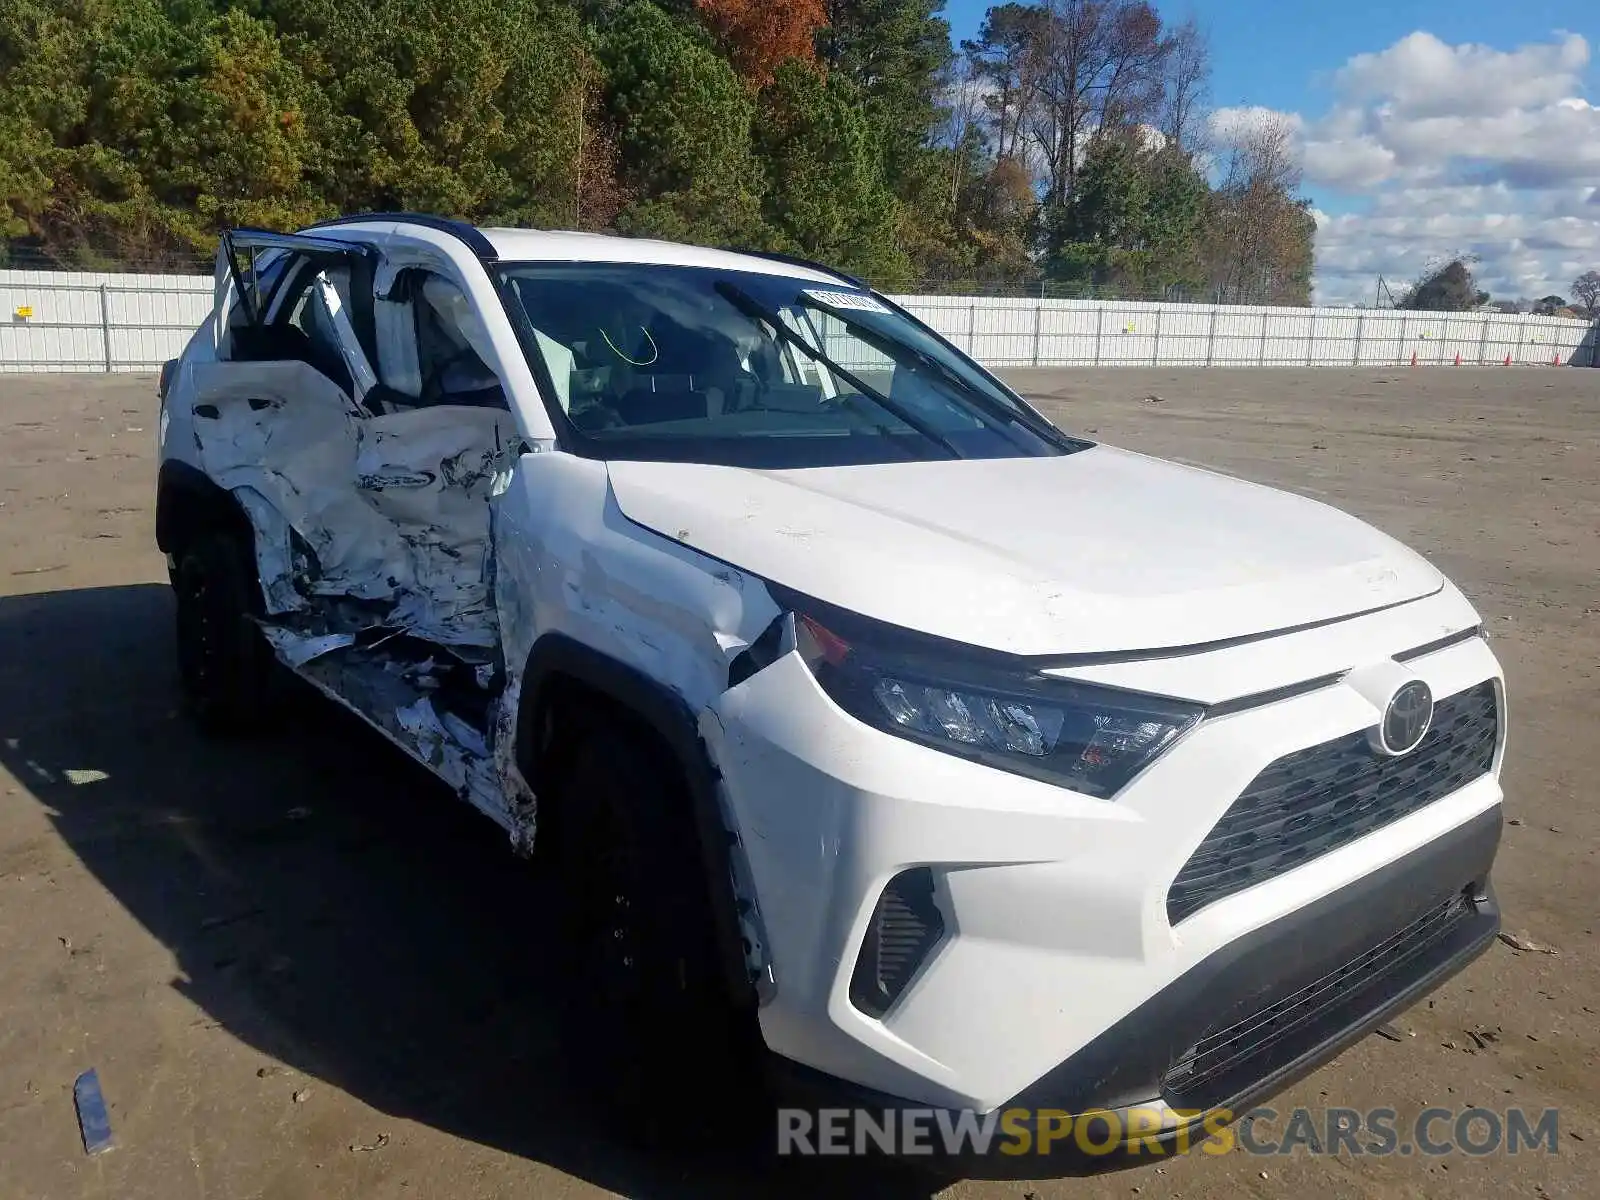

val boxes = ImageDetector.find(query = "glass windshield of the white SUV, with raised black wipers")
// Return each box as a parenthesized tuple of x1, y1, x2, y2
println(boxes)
(499, 262, 1086, 467)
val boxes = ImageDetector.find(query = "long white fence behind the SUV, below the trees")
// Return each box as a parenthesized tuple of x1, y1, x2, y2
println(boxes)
(0, 270, 1600, 371)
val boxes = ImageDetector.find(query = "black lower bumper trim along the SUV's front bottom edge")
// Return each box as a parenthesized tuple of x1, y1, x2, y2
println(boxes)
(774, 806, 1501, 1178)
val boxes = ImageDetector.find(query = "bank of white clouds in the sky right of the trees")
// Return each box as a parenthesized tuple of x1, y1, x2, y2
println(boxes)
(1280, 32, 1600, 304)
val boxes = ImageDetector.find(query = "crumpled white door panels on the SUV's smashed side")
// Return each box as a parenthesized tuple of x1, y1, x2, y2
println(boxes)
(194, 362, 517, 648)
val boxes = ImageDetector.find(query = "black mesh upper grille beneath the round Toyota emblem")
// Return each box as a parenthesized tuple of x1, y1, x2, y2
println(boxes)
(1166, 680, 1499, 925)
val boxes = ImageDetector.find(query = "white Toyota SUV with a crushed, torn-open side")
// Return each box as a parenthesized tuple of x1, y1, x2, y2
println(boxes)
(157, 214, 1506, 1174)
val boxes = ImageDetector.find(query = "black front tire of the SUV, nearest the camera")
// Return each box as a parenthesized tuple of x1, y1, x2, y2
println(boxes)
(554, 715, 770, 1154)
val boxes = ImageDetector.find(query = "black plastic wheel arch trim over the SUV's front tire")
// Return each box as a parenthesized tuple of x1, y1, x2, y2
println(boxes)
(517, 634, 757, 1008)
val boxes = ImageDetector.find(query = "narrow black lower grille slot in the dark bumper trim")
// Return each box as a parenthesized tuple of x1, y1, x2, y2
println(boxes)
(1162, 893, 1475, 1107)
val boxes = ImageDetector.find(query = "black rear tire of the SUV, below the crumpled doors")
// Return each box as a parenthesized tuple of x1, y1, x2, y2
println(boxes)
(173, 531, 277, 734)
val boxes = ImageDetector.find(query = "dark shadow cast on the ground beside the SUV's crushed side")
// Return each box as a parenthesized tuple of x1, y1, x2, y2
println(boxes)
(0, 584, 934, 1197)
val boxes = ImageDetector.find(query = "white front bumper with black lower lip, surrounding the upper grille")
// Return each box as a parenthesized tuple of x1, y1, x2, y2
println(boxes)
(702, 597, 1501, 1139)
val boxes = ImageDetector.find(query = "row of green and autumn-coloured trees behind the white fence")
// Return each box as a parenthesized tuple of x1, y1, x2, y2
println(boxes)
(0, 0, 1310, 299)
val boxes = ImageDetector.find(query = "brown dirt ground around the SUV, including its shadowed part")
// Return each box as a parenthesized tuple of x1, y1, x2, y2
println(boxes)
(0, 368, 1600, 1200)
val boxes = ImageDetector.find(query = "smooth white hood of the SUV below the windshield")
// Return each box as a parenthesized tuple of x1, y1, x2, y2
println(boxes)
(610, 446, 1443, 654)
